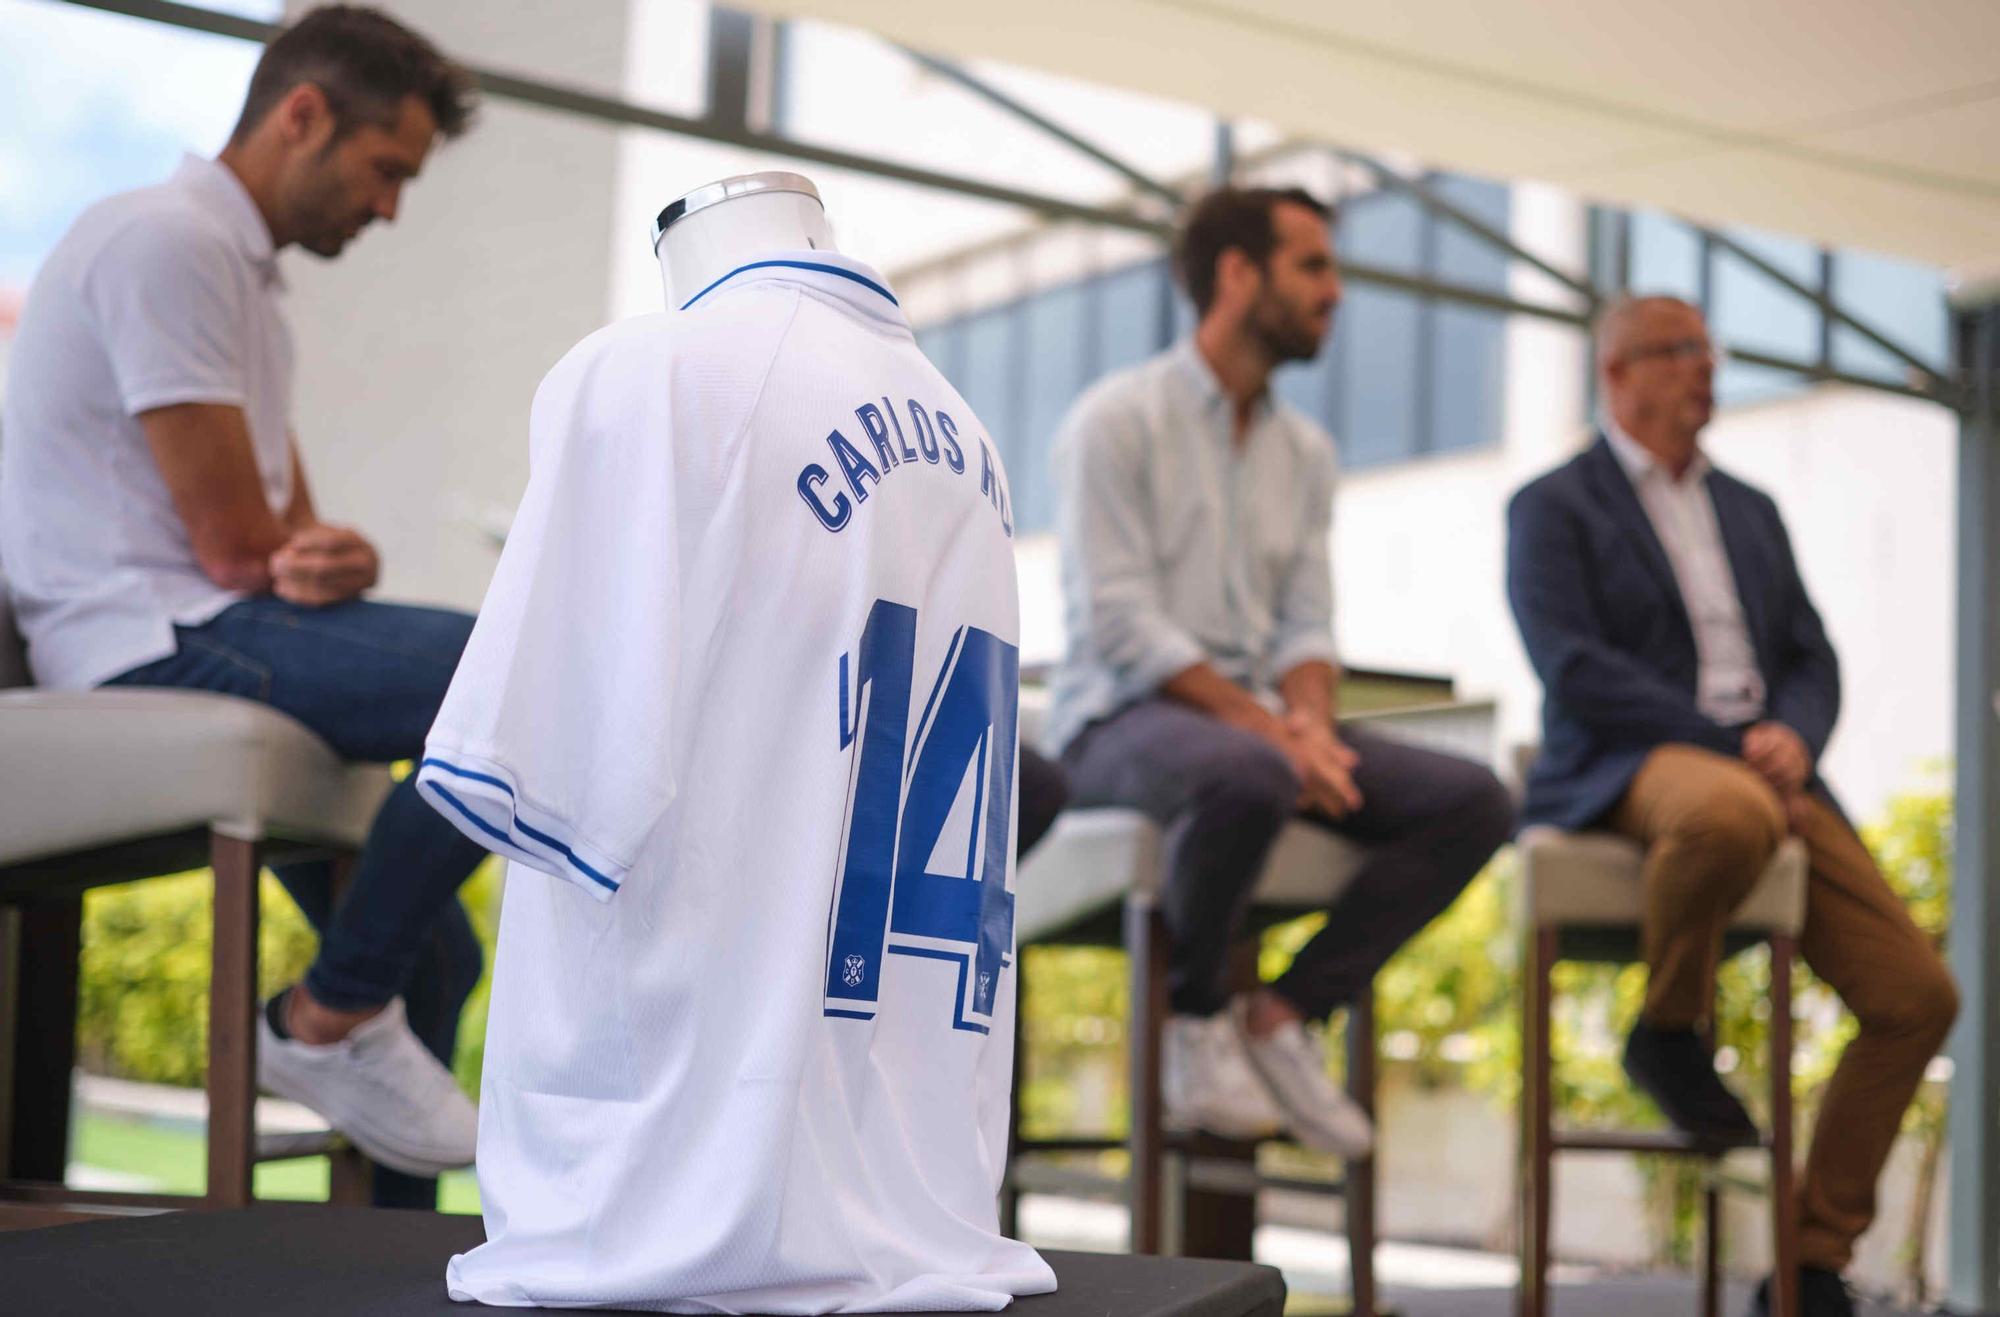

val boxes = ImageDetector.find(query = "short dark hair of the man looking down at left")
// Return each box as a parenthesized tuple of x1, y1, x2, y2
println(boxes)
(230, 4, 478, 142)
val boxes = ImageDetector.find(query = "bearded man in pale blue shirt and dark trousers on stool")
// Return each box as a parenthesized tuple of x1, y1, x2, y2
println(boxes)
(1050, 188, 1512, 1157)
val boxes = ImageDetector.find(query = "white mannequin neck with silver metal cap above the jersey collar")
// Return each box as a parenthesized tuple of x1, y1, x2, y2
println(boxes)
(652, 170, 838, 310)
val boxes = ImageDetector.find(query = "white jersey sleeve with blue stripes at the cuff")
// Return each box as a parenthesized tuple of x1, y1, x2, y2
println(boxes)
(416, 334, 682, 901)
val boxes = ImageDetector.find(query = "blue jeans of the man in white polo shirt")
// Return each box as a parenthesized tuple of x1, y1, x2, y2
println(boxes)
(106, 596, 486, 1207)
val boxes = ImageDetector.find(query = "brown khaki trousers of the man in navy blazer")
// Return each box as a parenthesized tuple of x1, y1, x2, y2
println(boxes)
(1608, 745, 1958, 1271)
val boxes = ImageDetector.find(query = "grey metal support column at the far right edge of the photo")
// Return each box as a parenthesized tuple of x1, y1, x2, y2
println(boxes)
(1950, 286, 2000, 1311)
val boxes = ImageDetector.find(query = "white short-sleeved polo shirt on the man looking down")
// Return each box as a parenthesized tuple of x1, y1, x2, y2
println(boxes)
(0, 156, 292, 689)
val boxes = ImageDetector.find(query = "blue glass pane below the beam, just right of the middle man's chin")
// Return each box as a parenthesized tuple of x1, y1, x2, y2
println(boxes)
(1334, 286, 1422, 466)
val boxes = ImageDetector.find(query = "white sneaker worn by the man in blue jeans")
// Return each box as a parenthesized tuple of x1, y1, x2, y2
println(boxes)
(256, 997, 480, 1175)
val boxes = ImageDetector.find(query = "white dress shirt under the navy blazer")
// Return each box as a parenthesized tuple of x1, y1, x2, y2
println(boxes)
(1604, 420, 1764, 727)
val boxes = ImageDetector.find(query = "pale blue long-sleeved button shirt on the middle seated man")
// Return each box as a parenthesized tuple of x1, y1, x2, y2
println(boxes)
(1048, 338, 1334, 751)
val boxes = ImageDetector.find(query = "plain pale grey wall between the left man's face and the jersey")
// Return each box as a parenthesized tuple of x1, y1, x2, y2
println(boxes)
(284, 0, 626, 608)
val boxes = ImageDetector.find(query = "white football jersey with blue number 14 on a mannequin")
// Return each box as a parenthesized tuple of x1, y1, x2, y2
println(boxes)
(418, 252, 1056, 1313)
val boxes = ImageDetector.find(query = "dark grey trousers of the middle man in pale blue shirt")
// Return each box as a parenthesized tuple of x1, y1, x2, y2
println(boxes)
(1062, 699, 1514, 1019)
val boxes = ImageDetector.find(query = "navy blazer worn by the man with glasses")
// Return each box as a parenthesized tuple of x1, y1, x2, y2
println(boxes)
(1506, 434, 1840, 829)
